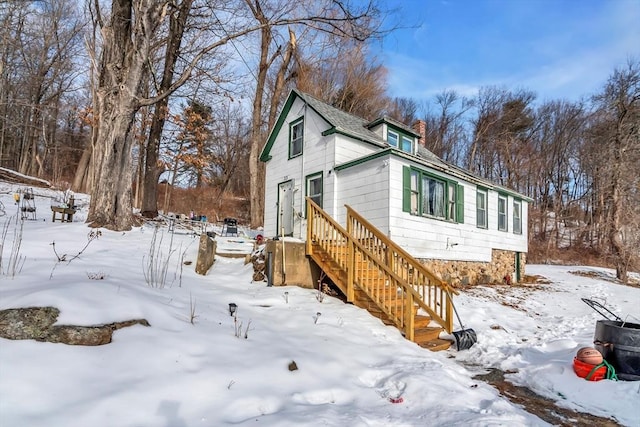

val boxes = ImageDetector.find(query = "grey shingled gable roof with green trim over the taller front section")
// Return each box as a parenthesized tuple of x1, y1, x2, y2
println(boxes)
(260, 89, 387, 162)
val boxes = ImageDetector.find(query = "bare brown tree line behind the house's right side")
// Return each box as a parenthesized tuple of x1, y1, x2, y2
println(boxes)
(404, 59, 640, 280)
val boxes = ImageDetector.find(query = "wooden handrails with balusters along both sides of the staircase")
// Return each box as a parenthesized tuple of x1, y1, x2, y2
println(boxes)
(306, 198, 453, 340)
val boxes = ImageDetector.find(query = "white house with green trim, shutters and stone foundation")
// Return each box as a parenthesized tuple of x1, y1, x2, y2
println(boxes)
(260, 90, 531, 284)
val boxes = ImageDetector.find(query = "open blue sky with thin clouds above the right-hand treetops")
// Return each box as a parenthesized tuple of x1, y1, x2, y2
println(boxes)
(378, 0, 640, 102)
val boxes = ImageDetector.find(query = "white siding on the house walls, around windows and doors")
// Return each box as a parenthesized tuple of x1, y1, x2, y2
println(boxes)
(264, 98, 528, 261)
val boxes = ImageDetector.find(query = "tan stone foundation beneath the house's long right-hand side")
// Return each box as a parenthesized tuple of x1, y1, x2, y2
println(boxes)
(419, 249, 527, 287)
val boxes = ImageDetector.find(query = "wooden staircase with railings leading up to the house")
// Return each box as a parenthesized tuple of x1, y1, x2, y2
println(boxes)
(306, 198, 457, 351)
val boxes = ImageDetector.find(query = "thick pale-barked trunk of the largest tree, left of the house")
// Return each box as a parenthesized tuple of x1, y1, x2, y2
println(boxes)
(87, 0, 164, 231)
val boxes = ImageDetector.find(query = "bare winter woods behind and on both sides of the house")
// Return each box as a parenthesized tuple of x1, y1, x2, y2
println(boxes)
(0, 0, 640, 278)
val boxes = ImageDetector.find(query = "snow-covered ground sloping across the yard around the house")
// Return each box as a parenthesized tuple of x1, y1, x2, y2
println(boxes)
(0, 182, 640, 427)
